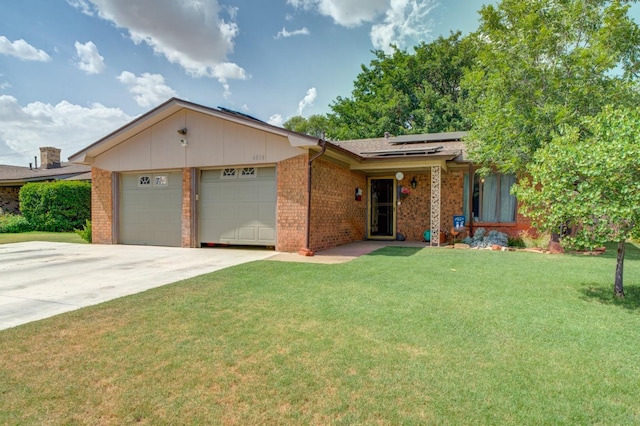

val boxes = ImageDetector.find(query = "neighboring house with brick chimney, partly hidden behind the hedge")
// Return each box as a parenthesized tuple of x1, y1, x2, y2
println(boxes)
(0, 147, 91, 214)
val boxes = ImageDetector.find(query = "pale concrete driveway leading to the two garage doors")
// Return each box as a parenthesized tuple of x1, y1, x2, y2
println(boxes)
(0, 242, 276, 330)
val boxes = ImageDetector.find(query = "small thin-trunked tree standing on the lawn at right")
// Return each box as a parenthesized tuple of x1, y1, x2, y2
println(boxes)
(517, 107, 640, 297)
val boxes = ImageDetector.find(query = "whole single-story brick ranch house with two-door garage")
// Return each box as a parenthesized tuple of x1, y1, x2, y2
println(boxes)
(70, 98, 529, 254)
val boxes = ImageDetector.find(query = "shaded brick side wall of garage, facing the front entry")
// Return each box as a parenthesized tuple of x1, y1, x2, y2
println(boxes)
(310, 158, 367, 251)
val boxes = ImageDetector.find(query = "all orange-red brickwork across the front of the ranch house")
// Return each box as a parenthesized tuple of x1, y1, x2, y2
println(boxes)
(91, 161, 530, 252)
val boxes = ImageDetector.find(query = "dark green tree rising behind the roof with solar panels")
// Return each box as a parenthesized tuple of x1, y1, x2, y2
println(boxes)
(328, 32, 475, 140)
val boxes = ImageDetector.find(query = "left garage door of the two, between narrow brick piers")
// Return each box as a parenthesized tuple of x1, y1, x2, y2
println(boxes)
(119, 172, 182, 247)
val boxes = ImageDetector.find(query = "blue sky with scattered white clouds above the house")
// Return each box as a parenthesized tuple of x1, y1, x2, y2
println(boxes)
(0, 0, 636, 166)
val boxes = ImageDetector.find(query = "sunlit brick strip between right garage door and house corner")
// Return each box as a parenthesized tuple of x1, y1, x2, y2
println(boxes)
(276, 154, 309, 252)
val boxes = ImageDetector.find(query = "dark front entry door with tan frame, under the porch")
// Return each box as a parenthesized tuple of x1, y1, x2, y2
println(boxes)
(368, 178, 396, 239)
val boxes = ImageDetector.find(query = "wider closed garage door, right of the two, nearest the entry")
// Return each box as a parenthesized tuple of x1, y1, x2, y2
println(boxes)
(199, 167, 276, 246)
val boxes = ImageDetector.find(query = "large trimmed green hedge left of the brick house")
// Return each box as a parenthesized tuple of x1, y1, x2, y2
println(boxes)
(20, 181, 91, 232)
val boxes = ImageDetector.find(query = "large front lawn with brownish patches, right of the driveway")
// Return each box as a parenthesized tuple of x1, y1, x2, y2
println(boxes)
(0, 245, 640, 425)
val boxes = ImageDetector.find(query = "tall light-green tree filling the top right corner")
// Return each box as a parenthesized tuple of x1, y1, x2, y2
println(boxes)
(462, 0, 640, 174)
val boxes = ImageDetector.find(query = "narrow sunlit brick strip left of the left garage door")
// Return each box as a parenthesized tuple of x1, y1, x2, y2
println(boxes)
(91, 167, 114, 244)
